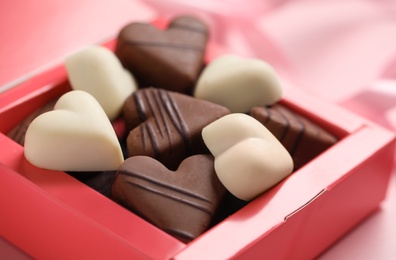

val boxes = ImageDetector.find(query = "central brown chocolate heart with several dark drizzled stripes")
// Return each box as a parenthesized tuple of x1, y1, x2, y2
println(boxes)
(124, 88, 229, 169)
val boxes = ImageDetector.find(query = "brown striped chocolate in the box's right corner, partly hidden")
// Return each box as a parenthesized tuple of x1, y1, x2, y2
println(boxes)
(250, 103, 337, 170)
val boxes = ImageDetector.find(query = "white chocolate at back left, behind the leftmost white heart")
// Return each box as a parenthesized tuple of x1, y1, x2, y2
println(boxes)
(65, 46, 137, 120)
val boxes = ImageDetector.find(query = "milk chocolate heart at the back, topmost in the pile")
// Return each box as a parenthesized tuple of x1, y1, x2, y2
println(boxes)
(115, 16, 208, 93)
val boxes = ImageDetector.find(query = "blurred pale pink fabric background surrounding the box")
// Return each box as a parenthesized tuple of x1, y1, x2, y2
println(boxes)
(0, 0, 396, 260)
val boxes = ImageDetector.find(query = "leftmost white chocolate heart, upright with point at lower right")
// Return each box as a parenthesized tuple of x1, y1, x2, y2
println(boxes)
(25, 90, 124, 171)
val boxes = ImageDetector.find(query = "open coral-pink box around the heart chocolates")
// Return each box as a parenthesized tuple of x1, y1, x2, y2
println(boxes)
(0, 19, 395, 259)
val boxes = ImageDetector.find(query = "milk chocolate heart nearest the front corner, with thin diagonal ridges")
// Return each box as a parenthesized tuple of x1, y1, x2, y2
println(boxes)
(111, 154, 225, 242)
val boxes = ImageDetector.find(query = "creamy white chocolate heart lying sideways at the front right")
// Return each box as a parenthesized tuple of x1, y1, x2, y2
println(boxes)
(202, 113, 293, 201)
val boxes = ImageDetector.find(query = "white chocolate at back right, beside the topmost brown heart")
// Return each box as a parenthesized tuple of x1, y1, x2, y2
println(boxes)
(194, 55, 282, 113)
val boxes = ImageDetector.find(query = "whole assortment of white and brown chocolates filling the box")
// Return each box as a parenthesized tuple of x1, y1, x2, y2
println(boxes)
(9, 16, 337, 243)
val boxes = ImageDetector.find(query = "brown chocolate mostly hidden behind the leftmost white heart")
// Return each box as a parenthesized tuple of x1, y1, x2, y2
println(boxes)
(7, 99, 57, 146)
